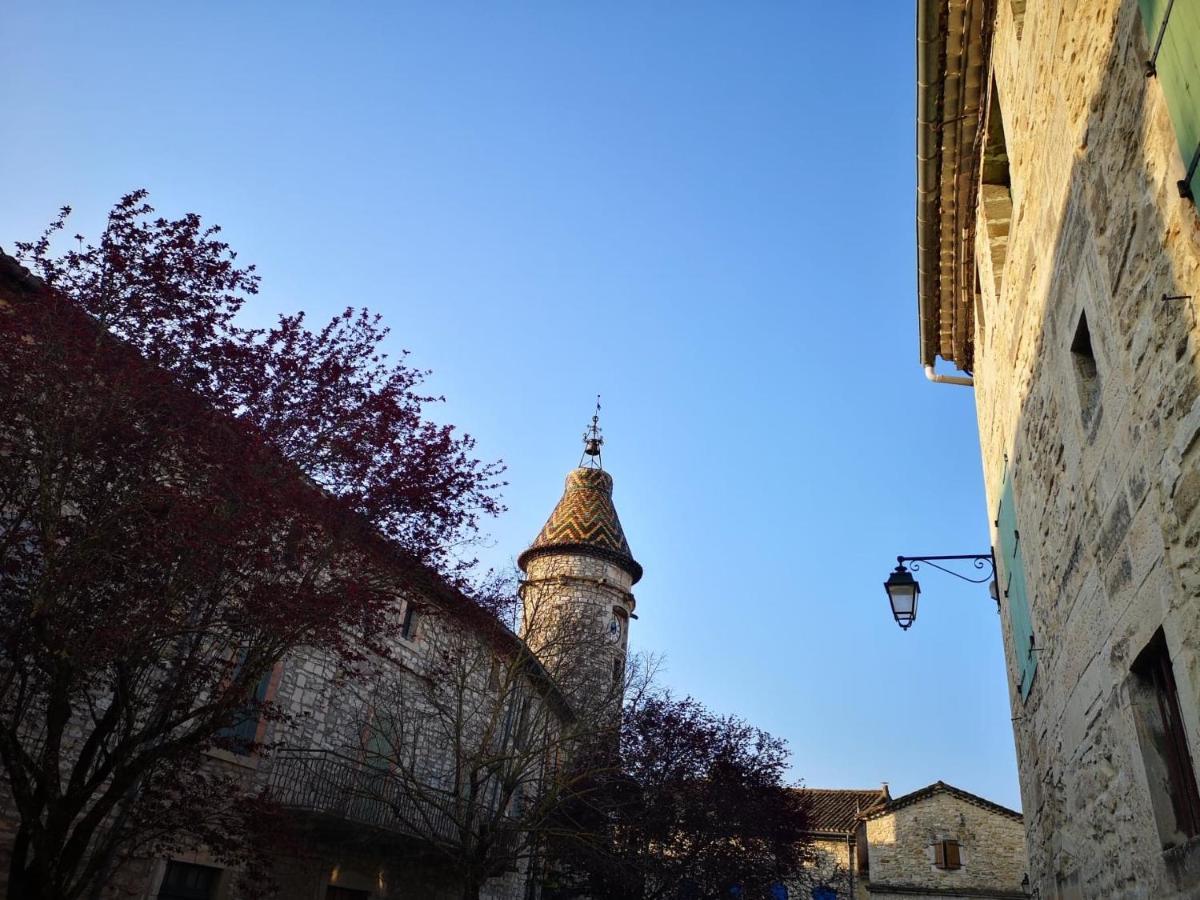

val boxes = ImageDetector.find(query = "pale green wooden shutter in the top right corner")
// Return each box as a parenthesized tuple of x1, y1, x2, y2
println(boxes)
(1138, 0, 1200, 198)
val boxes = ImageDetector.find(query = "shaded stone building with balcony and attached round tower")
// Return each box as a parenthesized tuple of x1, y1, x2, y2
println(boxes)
(137, 457, 642, 900)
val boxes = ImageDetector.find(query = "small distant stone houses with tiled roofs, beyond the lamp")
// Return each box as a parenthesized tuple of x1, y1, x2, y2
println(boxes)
(790, 781, 1026, 900)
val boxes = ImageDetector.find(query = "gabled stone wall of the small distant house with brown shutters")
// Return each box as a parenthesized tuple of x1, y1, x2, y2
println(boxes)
(866, 792, 1025, 898)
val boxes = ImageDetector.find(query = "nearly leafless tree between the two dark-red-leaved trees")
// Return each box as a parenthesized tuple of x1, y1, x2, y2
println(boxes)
(343, 578, 652, 900)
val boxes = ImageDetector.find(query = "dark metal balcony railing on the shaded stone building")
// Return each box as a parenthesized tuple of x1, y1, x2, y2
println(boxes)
(270, 750, 461, 845)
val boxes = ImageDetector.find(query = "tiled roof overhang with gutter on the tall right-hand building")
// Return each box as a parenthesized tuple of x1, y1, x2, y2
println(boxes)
(917, 0, 996, 372)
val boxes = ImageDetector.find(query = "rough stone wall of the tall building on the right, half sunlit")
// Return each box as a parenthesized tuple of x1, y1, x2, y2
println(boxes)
(974, 0, 1200, 899)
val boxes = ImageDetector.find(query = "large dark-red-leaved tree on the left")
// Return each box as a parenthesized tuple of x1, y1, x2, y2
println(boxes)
(0, 191, 500, 900)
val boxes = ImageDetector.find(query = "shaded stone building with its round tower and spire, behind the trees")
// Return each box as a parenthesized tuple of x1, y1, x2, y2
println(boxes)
(0, 253, 642, 900)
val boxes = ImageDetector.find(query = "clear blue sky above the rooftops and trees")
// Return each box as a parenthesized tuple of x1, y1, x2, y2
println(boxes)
(0, 0, 1020, 806)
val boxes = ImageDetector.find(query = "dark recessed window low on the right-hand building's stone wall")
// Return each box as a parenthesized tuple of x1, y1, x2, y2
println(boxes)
(1129, 629, 1200, 850)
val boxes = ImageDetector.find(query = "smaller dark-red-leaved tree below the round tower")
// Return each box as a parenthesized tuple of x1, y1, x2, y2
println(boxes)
(553, 691, 809, 900)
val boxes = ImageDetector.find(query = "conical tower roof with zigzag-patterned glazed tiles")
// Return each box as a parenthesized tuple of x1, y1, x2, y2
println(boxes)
(517, 467, 642, 583)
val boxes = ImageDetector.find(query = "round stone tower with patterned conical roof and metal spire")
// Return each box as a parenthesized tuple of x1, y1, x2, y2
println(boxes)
(517, 416, 642, 714)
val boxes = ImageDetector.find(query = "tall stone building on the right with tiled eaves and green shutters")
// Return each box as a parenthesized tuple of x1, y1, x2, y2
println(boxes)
(912, 0, 1200, 899)
